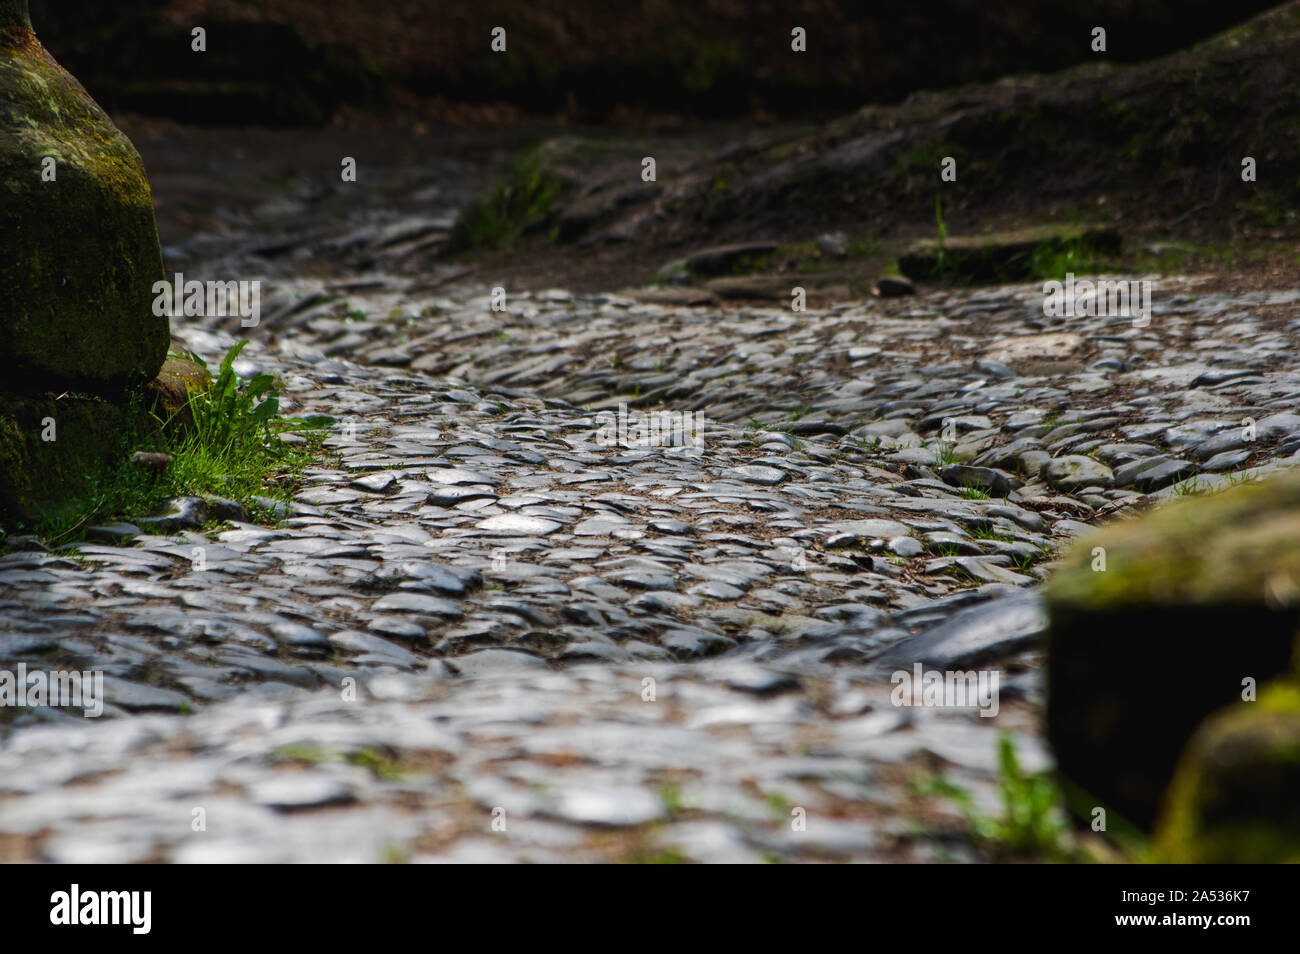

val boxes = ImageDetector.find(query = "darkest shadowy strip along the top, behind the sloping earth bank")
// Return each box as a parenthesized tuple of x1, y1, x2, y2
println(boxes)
(31, 0, 1275, 126)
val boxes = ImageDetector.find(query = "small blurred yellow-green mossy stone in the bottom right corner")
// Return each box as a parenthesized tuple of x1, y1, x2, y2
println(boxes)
(1153, 681, 1300, 864)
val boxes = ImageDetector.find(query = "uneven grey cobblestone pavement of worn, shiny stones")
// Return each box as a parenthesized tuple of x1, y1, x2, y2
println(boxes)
(0, 192, 1300, 862)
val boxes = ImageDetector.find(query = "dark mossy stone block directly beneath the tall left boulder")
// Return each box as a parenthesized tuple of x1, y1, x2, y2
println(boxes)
(0, 394, 129, 525)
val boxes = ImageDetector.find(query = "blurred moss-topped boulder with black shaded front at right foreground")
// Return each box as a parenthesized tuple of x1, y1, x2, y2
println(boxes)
(1047, 473, 1300, 828)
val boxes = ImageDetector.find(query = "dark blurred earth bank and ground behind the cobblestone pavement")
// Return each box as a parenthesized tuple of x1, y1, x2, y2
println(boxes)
(22, 0, 1300, 298)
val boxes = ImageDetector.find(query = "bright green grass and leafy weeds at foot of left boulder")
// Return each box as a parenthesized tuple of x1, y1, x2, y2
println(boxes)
(13, 342, 334, 546)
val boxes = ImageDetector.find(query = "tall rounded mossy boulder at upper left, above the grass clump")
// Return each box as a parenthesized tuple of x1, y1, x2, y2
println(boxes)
(0, 0, 169, 395)
